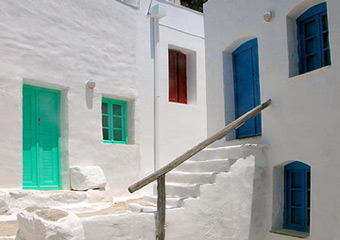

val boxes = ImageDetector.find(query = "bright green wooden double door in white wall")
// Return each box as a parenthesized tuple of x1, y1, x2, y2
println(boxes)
(23, 85, 60, 190)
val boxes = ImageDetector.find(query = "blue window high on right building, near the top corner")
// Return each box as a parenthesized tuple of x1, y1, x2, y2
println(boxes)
(296, 3, 331, 74)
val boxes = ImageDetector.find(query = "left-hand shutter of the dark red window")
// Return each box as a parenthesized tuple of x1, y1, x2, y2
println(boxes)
(169, 50, 178, 102)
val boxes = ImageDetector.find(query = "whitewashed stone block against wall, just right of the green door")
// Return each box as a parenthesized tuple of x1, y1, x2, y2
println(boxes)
(70, 166, 106, 190)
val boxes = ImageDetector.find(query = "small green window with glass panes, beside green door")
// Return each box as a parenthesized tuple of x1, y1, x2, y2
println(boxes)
(102, 98, 128, 144)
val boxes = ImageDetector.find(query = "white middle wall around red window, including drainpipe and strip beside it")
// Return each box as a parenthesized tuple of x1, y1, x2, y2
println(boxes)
(136, 1, 207, 172)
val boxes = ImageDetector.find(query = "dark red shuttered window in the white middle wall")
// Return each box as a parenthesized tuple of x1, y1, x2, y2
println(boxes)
(169, 49, 187, 104)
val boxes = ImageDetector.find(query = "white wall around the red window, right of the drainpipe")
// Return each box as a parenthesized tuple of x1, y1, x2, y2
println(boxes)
(156, 2, 207, 168)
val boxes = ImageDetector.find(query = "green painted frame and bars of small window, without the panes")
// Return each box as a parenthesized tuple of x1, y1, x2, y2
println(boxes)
(101, 97, 128, 144)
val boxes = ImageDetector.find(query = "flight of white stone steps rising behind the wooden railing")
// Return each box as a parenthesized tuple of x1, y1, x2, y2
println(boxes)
(129, 144, 254, 213)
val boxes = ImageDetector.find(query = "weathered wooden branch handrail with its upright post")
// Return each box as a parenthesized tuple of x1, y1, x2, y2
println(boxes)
(129, 99, 271, 240)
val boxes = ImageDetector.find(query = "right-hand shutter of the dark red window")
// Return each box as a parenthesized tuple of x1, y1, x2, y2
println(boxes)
(177, 52, 187, 103)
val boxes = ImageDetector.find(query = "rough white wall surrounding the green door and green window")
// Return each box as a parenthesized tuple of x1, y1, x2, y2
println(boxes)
(0, 0, 140, 195)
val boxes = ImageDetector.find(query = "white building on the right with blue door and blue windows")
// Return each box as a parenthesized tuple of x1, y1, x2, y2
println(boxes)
(204, 0, 340, 240)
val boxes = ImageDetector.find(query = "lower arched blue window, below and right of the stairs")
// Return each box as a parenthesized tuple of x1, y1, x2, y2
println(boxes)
(284, 162, 311, 232)
